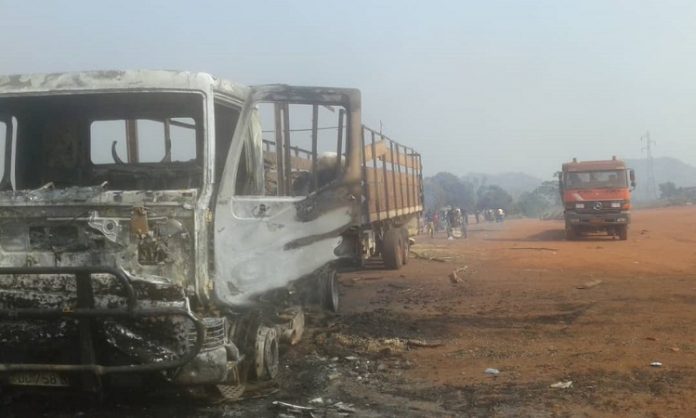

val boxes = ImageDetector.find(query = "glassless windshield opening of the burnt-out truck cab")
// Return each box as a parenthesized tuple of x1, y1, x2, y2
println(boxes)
(0, 90, 207, 190)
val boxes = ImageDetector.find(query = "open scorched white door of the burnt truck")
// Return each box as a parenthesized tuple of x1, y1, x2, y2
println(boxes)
(214, 85, 360, 304)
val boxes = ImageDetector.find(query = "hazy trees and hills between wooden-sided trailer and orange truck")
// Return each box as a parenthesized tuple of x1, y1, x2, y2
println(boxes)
(423, 172, 561, 218)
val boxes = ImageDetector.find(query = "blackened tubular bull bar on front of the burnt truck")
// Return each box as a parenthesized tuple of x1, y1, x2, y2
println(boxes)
(0, 266, 205, 376)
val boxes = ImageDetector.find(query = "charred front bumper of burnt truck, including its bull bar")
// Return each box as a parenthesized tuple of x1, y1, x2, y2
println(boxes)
(0, 267, 227, 390)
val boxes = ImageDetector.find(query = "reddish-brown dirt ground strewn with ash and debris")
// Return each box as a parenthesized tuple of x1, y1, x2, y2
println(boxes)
(9, 207, 696, 417)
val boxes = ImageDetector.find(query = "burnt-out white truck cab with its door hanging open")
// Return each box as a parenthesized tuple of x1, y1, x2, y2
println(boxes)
(0, 71, 362, 398)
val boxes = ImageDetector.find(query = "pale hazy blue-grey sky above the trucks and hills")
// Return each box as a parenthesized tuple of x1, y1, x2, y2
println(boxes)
(0, 0, 696, 177)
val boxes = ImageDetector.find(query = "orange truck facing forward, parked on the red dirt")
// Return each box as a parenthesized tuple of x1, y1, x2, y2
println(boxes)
(559, 157, 636, 240)
